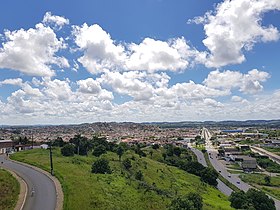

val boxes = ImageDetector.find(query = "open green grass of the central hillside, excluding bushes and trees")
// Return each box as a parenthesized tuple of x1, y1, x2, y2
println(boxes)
(12, 149, 232, 210)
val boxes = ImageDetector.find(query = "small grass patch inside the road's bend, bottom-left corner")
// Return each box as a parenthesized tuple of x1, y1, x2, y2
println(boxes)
(0, 169, 20, 210)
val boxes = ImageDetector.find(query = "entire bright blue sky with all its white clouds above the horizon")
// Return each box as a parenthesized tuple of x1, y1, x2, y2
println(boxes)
(0, 0, 280, 125)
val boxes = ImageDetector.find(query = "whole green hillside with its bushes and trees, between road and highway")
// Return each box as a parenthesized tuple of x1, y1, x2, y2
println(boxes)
(12, 136, 232, 210)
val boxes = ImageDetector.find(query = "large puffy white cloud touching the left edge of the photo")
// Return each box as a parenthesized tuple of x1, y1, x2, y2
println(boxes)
(0, 24, 69, 76)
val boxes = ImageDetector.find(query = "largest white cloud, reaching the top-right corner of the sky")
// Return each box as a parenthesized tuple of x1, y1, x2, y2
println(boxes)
(189, 0, 280, 67)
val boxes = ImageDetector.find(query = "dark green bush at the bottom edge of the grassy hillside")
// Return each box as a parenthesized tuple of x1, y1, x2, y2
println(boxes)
(169, 193, 203, 210)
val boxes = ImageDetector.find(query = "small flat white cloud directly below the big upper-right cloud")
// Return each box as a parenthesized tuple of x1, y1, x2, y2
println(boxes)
(203, 69, 270, 94)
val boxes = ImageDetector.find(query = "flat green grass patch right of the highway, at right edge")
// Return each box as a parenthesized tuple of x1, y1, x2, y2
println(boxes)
(240, 174, 280, 199)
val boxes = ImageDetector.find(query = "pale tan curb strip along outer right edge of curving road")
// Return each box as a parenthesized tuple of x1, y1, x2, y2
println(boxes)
(9, 158, 64, 210)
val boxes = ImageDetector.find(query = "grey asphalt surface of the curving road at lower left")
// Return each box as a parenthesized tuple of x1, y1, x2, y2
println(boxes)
(0, 155, 56, 210)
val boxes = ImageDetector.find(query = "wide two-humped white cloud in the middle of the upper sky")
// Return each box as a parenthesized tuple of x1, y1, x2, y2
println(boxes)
(72, 23, 202, 74)
